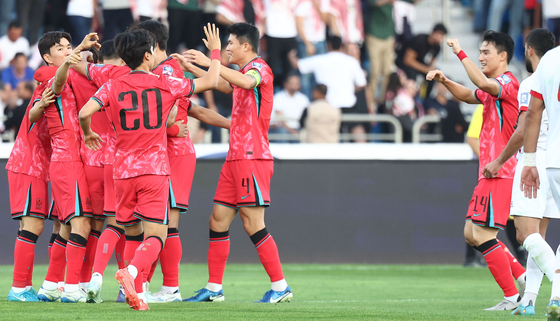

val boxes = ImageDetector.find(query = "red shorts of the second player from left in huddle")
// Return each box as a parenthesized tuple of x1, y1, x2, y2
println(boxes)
(50, 162, 93, 224)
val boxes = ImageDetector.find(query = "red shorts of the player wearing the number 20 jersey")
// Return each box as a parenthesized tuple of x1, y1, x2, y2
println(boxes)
(115, 175, 169, 226)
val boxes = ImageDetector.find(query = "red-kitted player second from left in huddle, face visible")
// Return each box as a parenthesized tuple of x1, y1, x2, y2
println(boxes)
(29, 32, 95, 303)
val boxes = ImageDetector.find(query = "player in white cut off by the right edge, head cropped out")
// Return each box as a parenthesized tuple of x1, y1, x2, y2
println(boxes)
(521, 36, 560, 320)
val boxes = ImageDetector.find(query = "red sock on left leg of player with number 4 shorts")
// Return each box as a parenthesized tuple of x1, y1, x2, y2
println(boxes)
(206, 230, 230, 292)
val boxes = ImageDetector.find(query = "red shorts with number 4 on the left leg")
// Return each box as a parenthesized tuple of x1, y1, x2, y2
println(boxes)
(214, 159, 274, 209)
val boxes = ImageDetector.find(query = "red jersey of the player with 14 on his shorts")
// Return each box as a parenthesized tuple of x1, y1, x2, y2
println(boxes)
(475, 71, 519, 179)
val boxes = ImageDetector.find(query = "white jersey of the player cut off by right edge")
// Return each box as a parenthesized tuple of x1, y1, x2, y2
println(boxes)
(531, 47, 560, 168)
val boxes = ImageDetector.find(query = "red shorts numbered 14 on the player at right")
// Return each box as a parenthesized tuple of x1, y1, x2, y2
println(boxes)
(467, 178, 513, 230)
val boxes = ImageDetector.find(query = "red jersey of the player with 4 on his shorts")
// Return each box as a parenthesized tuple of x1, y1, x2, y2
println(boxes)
(226, 57, 274, 161)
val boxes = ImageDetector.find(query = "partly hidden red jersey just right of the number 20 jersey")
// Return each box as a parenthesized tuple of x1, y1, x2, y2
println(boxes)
(152, 57, 195, 156)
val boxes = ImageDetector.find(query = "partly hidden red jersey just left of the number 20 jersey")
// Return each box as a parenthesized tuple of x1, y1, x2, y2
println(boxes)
(86, 64, 130, 165)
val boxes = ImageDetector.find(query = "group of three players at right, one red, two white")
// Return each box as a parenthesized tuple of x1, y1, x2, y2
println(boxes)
(426, 29, 560, 320)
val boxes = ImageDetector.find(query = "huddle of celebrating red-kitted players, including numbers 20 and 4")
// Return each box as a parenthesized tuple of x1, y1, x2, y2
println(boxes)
(6, 20, 293, 310)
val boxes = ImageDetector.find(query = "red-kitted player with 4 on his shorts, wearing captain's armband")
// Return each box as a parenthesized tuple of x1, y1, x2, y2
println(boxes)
(178, 23, 293, 303)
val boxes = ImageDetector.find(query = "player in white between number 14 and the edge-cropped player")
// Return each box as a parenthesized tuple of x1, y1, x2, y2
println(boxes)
(482, 29, 560, 315)
